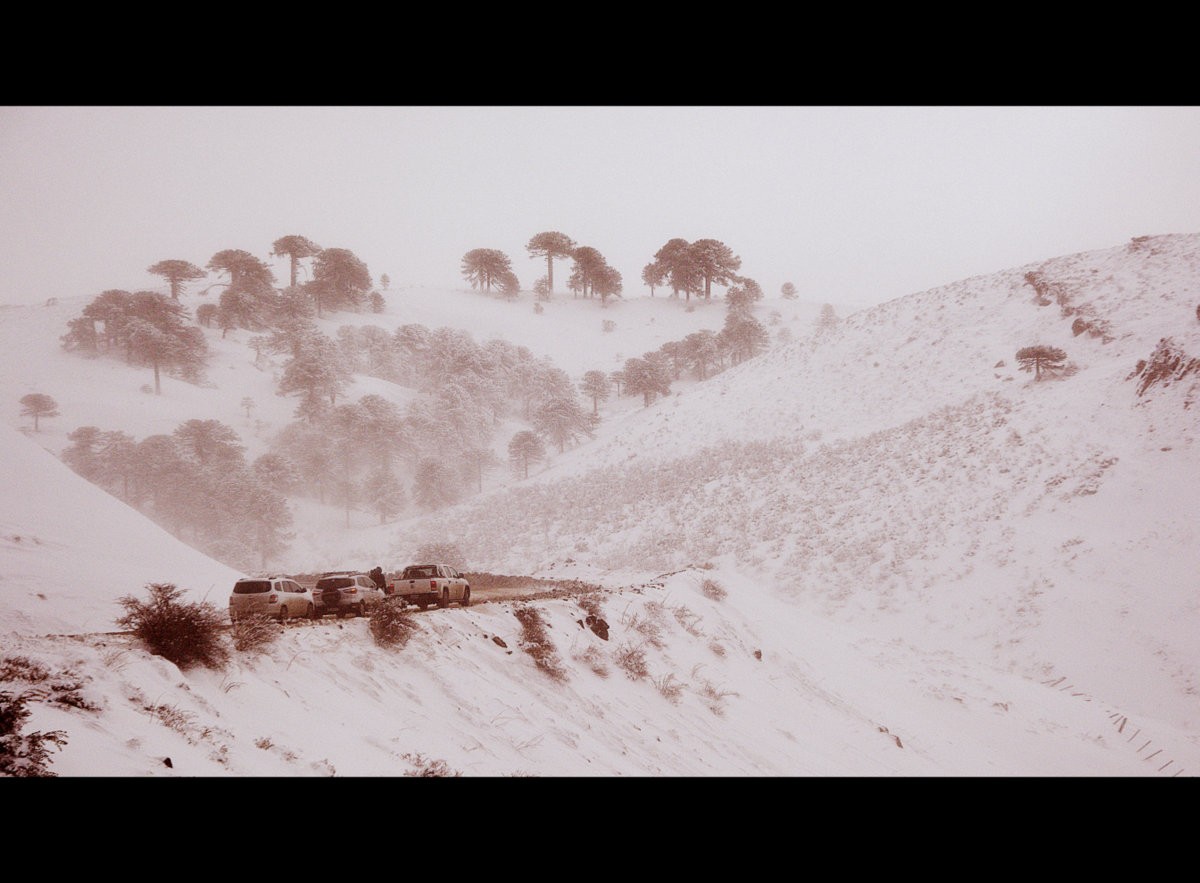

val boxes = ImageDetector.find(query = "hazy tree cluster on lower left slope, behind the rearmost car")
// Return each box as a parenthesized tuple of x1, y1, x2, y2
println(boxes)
(62, 420, 295, 570)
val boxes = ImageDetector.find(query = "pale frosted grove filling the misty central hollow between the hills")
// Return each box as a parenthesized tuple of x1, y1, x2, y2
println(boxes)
(265, 324, 598, 522)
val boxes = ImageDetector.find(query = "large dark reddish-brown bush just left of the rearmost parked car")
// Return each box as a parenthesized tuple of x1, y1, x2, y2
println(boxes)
(116, 583, 229, 668)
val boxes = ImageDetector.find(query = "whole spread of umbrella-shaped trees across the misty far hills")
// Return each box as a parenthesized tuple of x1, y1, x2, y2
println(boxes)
(49, 232, 806, 567)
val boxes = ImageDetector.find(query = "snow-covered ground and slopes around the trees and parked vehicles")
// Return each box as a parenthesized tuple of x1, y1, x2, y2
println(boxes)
(0, 235, 1200, 776)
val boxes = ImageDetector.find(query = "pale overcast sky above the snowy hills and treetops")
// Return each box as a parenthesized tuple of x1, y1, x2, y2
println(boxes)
(7, 106, 1200, 305)
